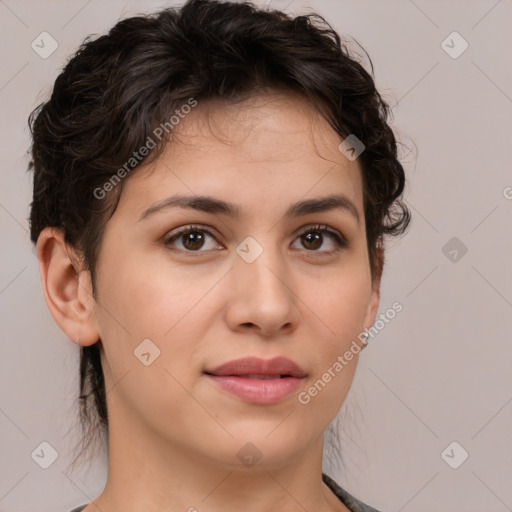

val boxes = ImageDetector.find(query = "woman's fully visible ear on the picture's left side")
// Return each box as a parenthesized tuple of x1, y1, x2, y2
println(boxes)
(36, 227, 100, 346)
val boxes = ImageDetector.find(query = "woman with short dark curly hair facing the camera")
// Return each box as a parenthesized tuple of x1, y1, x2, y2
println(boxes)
(30, 0, 409, 512)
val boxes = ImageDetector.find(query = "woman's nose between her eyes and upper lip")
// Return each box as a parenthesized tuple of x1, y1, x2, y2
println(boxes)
(226, 242, 299, 337)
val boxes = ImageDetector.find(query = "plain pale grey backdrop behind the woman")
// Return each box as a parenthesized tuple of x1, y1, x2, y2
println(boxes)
(0, 0, 512, 512)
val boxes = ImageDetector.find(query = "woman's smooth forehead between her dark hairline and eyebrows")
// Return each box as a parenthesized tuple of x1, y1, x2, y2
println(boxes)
(119, 93, 362, 213)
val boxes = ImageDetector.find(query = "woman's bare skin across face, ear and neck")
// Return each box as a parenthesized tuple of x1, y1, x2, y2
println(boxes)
(37, 93, 380, 512)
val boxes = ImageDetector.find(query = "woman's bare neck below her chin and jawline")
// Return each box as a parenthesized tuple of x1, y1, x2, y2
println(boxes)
(84, 408, 348, 512)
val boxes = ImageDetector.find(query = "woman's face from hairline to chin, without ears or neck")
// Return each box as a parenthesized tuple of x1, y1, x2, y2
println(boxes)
(89, 94, 378, 467)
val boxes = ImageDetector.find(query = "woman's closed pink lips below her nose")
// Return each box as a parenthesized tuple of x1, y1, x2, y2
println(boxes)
(205, 357, 306, 405)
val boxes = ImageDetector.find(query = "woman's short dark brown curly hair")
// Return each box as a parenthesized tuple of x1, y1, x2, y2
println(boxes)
(29, 0, 410, 468)
